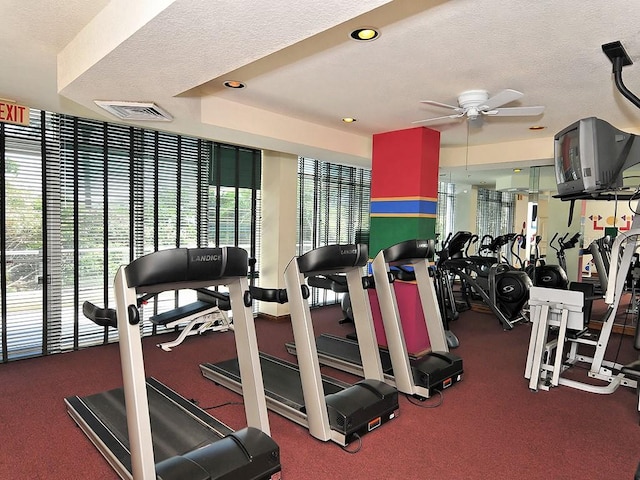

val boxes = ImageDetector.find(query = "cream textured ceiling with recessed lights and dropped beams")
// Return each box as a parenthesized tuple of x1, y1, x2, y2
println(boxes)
(0, 0, 640, 186)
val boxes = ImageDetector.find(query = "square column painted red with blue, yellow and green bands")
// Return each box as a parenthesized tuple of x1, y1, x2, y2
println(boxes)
(369, 127, 440, 355)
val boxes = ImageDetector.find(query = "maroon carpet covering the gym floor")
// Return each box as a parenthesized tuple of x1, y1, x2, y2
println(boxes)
(0, 307, 640, 480)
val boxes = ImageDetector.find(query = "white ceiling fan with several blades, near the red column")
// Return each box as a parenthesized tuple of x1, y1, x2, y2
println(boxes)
(411, 89, 544, 124)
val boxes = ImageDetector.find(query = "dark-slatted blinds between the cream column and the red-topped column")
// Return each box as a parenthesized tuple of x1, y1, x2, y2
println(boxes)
(297, 157, 371, 306)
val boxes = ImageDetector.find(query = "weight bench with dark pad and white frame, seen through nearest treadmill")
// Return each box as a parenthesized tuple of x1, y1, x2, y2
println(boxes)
(150, 289, 233, 352)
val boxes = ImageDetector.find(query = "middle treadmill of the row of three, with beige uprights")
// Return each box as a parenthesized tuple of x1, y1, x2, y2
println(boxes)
(200, 244, 398, 447)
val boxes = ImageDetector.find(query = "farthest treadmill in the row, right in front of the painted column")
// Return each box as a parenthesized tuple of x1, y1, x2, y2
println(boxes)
(286, 240, 463, 399)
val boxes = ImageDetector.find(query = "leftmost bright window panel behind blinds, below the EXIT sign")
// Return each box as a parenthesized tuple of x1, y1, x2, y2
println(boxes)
(0, 110, 45, 359)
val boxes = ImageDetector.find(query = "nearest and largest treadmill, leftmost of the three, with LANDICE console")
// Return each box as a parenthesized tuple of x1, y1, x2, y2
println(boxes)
(65, 247, 281, 480)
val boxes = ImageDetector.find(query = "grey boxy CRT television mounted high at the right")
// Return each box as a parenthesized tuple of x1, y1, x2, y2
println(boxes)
(554, 117, 640, 199)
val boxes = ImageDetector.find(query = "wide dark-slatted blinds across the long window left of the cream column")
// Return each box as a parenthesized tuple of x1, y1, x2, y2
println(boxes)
(0, 110, 260, 362)
